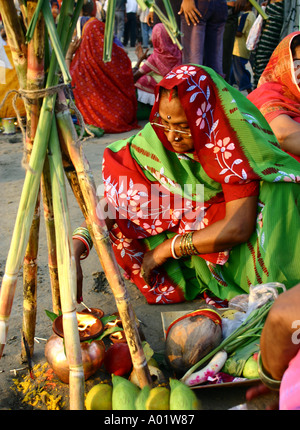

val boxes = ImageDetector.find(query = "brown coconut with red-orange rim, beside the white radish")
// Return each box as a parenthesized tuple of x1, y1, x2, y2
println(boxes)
(165, 309, 222, 375)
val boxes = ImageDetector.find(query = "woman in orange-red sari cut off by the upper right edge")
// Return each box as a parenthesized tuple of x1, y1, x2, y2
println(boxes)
(248, 31, 300, 161)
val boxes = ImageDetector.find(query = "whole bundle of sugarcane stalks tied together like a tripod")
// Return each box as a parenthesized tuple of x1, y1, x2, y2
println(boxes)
(0, 0, 180, 409)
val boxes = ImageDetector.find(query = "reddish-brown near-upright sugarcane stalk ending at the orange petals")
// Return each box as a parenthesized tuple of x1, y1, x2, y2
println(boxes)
(21, 0, 44, 359)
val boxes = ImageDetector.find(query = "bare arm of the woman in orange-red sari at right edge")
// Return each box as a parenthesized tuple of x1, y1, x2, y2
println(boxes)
(270, 114, 300, 155)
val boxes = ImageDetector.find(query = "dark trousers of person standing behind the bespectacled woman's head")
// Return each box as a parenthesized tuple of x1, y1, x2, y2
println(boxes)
(181, 0, 228, 76)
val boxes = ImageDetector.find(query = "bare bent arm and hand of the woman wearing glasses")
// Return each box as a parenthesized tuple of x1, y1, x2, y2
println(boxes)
(142, 196, 257, 285)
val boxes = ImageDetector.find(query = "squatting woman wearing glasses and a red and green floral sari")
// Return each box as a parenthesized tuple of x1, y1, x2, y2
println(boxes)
(74, 65, 300, 304)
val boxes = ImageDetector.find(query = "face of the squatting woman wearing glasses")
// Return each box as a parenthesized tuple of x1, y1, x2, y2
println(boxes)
(158, 94, 194, 153)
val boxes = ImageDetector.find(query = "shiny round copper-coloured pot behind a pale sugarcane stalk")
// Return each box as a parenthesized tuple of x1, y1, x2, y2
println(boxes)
(45, 334, 105, 384)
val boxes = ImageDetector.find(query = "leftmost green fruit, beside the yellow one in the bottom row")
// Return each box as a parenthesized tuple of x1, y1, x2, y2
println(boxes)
(112, 374, 141, 411)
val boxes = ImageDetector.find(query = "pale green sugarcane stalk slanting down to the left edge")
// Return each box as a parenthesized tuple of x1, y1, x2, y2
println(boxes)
(0, 0, 70, 358)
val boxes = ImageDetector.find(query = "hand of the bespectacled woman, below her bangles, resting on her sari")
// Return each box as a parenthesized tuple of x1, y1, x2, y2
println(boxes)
(141, 241, 171, 286)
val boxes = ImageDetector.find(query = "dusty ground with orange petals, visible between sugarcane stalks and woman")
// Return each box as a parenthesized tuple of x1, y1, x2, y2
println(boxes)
(0, 117, 277, 411)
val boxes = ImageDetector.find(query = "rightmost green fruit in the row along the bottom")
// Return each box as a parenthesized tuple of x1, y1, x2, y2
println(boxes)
(170, 378, 200, 411)
